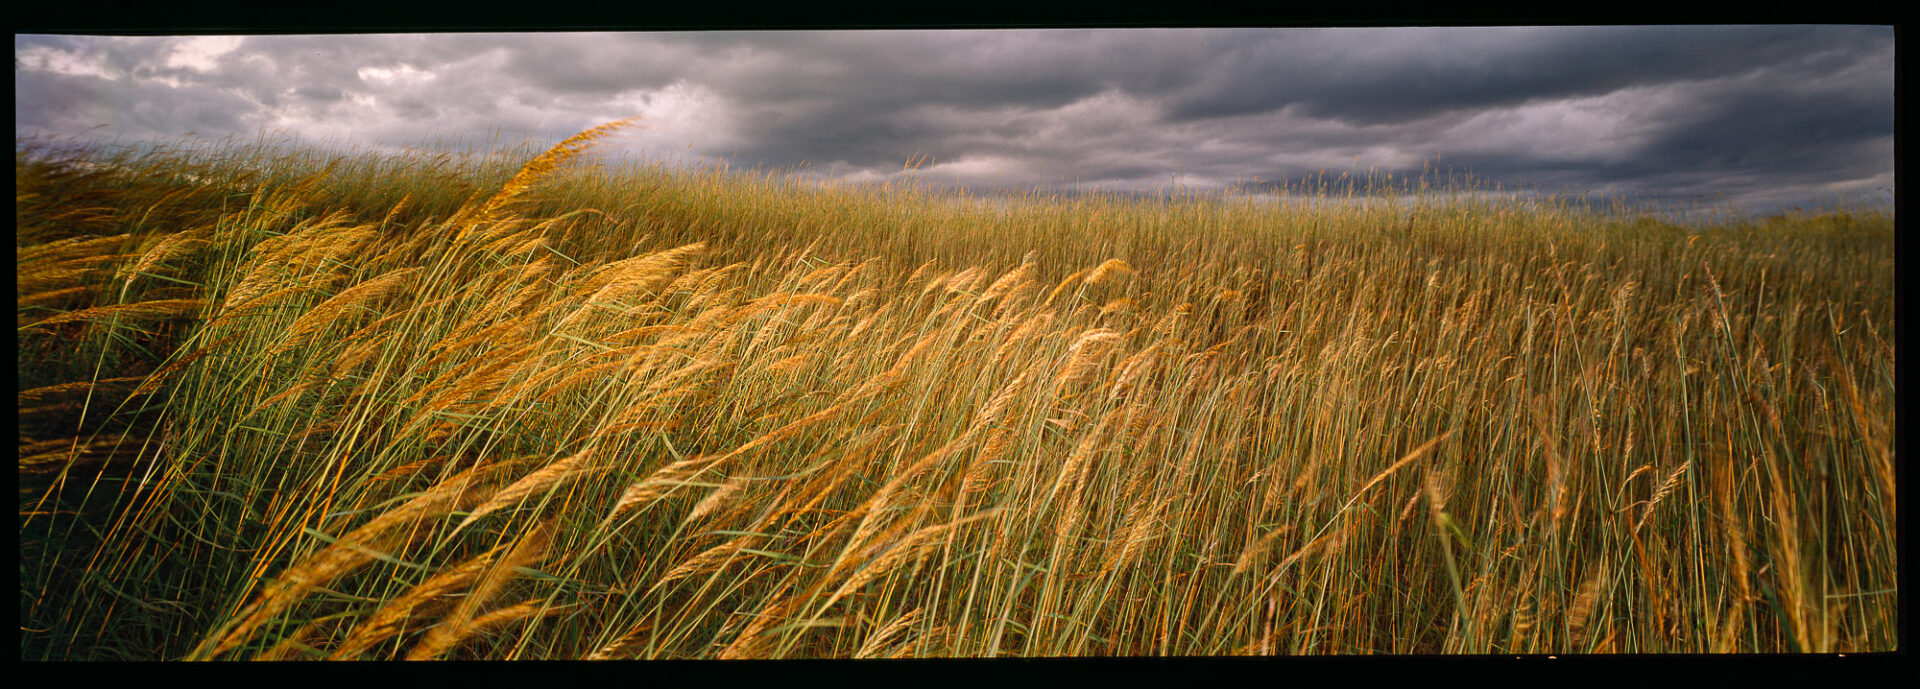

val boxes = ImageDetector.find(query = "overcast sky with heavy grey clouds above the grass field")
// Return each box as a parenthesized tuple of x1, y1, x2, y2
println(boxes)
(13, 27, 1895, 207)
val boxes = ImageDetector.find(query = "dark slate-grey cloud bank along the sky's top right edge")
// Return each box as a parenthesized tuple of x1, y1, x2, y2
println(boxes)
(1169, 27, 1893, 123)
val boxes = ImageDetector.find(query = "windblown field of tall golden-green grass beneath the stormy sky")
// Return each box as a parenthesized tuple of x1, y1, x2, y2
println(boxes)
(15, 125, 1899, 660)
